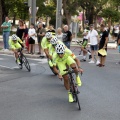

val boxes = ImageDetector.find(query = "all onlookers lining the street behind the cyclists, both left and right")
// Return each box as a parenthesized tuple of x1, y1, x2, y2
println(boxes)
(1, 17, 120, 66)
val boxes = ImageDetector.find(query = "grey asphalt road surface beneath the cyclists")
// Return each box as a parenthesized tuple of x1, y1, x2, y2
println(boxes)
(0, 49, 120, 120)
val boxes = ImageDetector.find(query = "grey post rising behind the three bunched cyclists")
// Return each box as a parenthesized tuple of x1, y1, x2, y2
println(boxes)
(56, 0, 62, 30)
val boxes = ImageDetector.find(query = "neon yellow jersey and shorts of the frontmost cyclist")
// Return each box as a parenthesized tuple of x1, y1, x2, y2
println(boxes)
(53, 48, 76, 75)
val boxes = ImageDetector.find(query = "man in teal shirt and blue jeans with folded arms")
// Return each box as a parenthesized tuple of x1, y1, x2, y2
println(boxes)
(1, 17, 12, 51)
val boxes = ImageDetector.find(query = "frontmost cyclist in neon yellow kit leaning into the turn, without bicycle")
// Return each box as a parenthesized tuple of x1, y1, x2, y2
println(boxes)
(52, 44, 83, 102)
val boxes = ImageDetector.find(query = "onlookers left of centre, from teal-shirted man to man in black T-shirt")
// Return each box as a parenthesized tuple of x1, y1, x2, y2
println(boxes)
(1, 17, 72, 55)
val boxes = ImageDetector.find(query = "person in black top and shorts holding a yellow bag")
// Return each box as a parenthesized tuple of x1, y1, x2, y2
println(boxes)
(98, 24, 109, 67)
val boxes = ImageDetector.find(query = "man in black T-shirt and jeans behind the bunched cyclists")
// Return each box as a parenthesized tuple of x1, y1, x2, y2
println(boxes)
(63, 25, 72, 49)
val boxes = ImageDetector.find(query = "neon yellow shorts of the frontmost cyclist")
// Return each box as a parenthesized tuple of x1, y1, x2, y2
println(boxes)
(57, 56, 75, 75)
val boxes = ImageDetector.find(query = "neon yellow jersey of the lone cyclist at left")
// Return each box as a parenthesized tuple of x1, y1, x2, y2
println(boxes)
(9, 37, 23, 49)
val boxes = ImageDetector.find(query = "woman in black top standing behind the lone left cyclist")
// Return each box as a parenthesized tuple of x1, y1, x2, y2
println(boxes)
(16, 20, 25, 41)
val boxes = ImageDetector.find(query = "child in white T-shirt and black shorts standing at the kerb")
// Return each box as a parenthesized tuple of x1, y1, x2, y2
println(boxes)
(28, 23, 36, 54)
